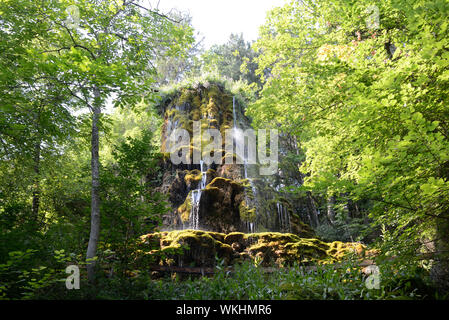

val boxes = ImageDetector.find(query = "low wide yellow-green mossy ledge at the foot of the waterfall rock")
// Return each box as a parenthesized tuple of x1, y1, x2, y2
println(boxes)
(140, 230, 365, 267)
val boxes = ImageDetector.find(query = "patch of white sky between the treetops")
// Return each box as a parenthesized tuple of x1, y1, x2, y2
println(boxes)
(154, 0, 286, 49)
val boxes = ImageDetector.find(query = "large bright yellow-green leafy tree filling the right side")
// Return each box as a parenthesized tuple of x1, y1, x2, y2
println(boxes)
(248, 0, 449, 286)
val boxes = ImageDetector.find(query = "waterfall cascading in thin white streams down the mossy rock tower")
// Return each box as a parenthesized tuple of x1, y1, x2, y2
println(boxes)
(161, 86, 308, 233)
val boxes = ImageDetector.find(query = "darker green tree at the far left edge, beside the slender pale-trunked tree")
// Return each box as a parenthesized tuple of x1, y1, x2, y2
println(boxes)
(0, 1, 75, 227)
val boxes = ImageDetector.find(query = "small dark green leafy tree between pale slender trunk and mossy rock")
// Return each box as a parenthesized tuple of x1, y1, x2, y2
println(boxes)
(101, 130, 167, 271)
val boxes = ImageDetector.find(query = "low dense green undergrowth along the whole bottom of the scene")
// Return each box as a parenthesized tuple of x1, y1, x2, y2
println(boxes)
(0, 252, 440, 300)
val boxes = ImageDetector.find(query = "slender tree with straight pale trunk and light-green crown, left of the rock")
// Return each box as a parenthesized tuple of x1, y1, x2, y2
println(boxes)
(0, 0, 192, 280)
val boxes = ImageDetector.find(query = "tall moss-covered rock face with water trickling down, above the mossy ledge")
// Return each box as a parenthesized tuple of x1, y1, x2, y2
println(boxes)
(159, 83, 313, 237)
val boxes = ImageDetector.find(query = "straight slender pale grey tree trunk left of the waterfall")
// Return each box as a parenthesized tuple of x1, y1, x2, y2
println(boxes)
(86, 88, 101, 283)
